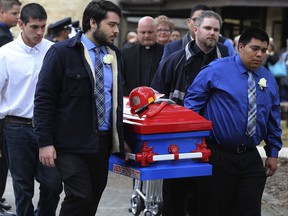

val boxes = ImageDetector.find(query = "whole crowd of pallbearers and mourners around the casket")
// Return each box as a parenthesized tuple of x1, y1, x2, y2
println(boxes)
(0, 0, 288, 216)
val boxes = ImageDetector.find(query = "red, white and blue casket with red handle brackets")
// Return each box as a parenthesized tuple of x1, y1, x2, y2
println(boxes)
(109, 91, 212, 180)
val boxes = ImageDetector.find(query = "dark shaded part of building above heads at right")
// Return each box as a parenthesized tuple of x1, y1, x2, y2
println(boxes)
(119, 0, 288, 50)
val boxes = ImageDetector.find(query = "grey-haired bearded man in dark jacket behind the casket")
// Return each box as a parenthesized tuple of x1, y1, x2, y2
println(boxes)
(151, 10, 229, 216)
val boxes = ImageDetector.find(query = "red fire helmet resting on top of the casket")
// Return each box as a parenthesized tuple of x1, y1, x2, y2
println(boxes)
(129, 86, 156, 114)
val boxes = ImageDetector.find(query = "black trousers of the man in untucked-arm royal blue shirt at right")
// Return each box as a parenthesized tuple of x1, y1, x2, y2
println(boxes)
(192, 144, 266, 216)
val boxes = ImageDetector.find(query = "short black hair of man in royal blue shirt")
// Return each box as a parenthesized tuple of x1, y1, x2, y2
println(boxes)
(239, 27, 269, 46)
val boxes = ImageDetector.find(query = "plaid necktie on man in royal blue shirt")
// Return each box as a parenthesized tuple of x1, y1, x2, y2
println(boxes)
(247, 71, 257, 137)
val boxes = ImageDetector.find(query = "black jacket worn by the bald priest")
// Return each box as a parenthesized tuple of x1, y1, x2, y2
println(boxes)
(122, 43, 164, 96)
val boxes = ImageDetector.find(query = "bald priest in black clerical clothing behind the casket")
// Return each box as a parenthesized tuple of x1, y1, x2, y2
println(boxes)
(122, 16, 164, 96)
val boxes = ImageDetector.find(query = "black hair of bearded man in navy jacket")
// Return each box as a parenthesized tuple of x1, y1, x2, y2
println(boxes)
(82, 0, 122, 33)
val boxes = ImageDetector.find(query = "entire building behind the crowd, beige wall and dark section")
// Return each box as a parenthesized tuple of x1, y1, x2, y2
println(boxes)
(12, 0, 288, 50)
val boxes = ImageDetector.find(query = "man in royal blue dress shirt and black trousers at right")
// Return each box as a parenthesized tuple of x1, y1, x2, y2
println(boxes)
(184, 27, 282, 216)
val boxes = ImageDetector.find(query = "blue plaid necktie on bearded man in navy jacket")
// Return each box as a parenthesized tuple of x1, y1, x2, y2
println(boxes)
(94, 47, 105, 126)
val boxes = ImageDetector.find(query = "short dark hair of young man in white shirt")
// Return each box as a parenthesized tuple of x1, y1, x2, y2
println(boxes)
(20, 3, 47, 24)
